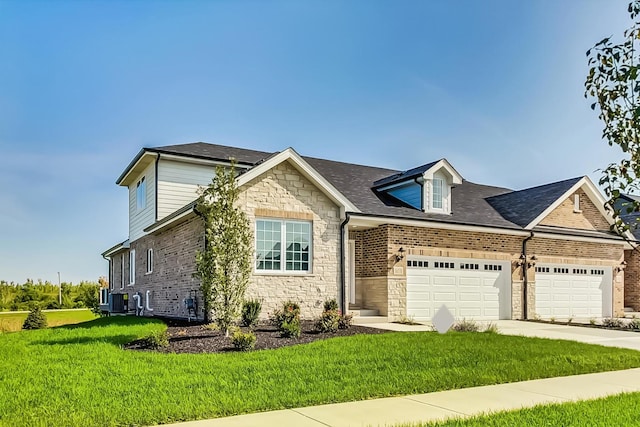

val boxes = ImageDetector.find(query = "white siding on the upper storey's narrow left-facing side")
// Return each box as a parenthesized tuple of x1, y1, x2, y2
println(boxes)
(129, 163, 156, 241)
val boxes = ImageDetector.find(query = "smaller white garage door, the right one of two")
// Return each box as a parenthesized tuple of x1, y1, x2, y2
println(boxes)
(535, 264, 612, 318)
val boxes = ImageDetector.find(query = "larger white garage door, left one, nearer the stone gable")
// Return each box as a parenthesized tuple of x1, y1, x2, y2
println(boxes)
(407, 257, 511, 321)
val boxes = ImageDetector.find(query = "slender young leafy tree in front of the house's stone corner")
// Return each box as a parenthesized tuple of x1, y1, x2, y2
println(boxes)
(195, 163, 253, 337)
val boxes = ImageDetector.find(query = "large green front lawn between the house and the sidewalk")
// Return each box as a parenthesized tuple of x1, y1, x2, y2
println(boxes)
(0, 317, 640, 426)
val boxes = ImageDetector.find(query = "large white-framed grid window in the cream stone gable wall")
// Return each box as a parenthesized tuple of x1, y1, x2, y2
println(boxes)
(256, 219, 311, 272)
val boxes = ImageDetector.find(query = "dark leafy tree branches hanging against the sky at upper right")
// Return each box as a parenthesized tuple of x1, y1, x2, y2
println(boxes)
(585, 0, 640, 232)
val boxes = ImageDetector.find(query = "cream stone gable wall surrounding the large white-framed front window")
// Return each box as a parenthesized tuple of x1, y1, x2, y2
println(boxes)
(239, 162, 342, 318)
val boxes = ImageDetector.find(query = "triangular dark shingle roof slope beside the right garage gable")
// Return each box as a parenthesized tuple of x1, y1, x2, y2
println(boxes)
(487, 177, 583, 227)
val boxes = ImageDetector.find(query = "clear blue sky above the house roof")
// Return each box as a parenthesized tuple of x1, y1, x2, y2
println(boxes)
(0, 0, 630, 283)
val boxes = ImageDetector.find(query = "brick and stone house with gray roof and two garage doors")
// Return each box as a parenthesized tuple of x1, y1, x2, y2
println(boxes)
(103, 142, 640, 320)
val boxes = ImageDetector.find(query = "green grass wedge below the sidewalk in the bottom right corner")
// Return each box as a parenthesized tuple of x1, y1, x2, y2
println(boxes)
(410, 393, 640, 427)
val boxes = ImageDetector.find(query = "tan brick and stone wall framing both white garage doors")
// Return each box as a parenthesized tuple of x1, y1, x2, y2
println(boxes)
(350, 224, 624, 318)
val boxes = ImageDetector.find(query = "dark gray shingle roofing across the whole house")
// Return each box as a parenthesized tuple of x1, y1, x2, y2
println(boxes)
(147, 142, 604, 236)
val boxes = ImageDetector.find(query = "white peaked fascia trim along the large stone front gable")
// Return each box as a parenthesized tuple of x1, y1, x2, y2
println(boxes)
(237, 148, 360, 212)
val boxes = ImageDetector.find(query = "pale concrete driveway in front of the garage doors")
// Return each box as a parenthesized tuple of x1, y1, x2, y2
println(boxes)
(363, 320, 640, 350)
